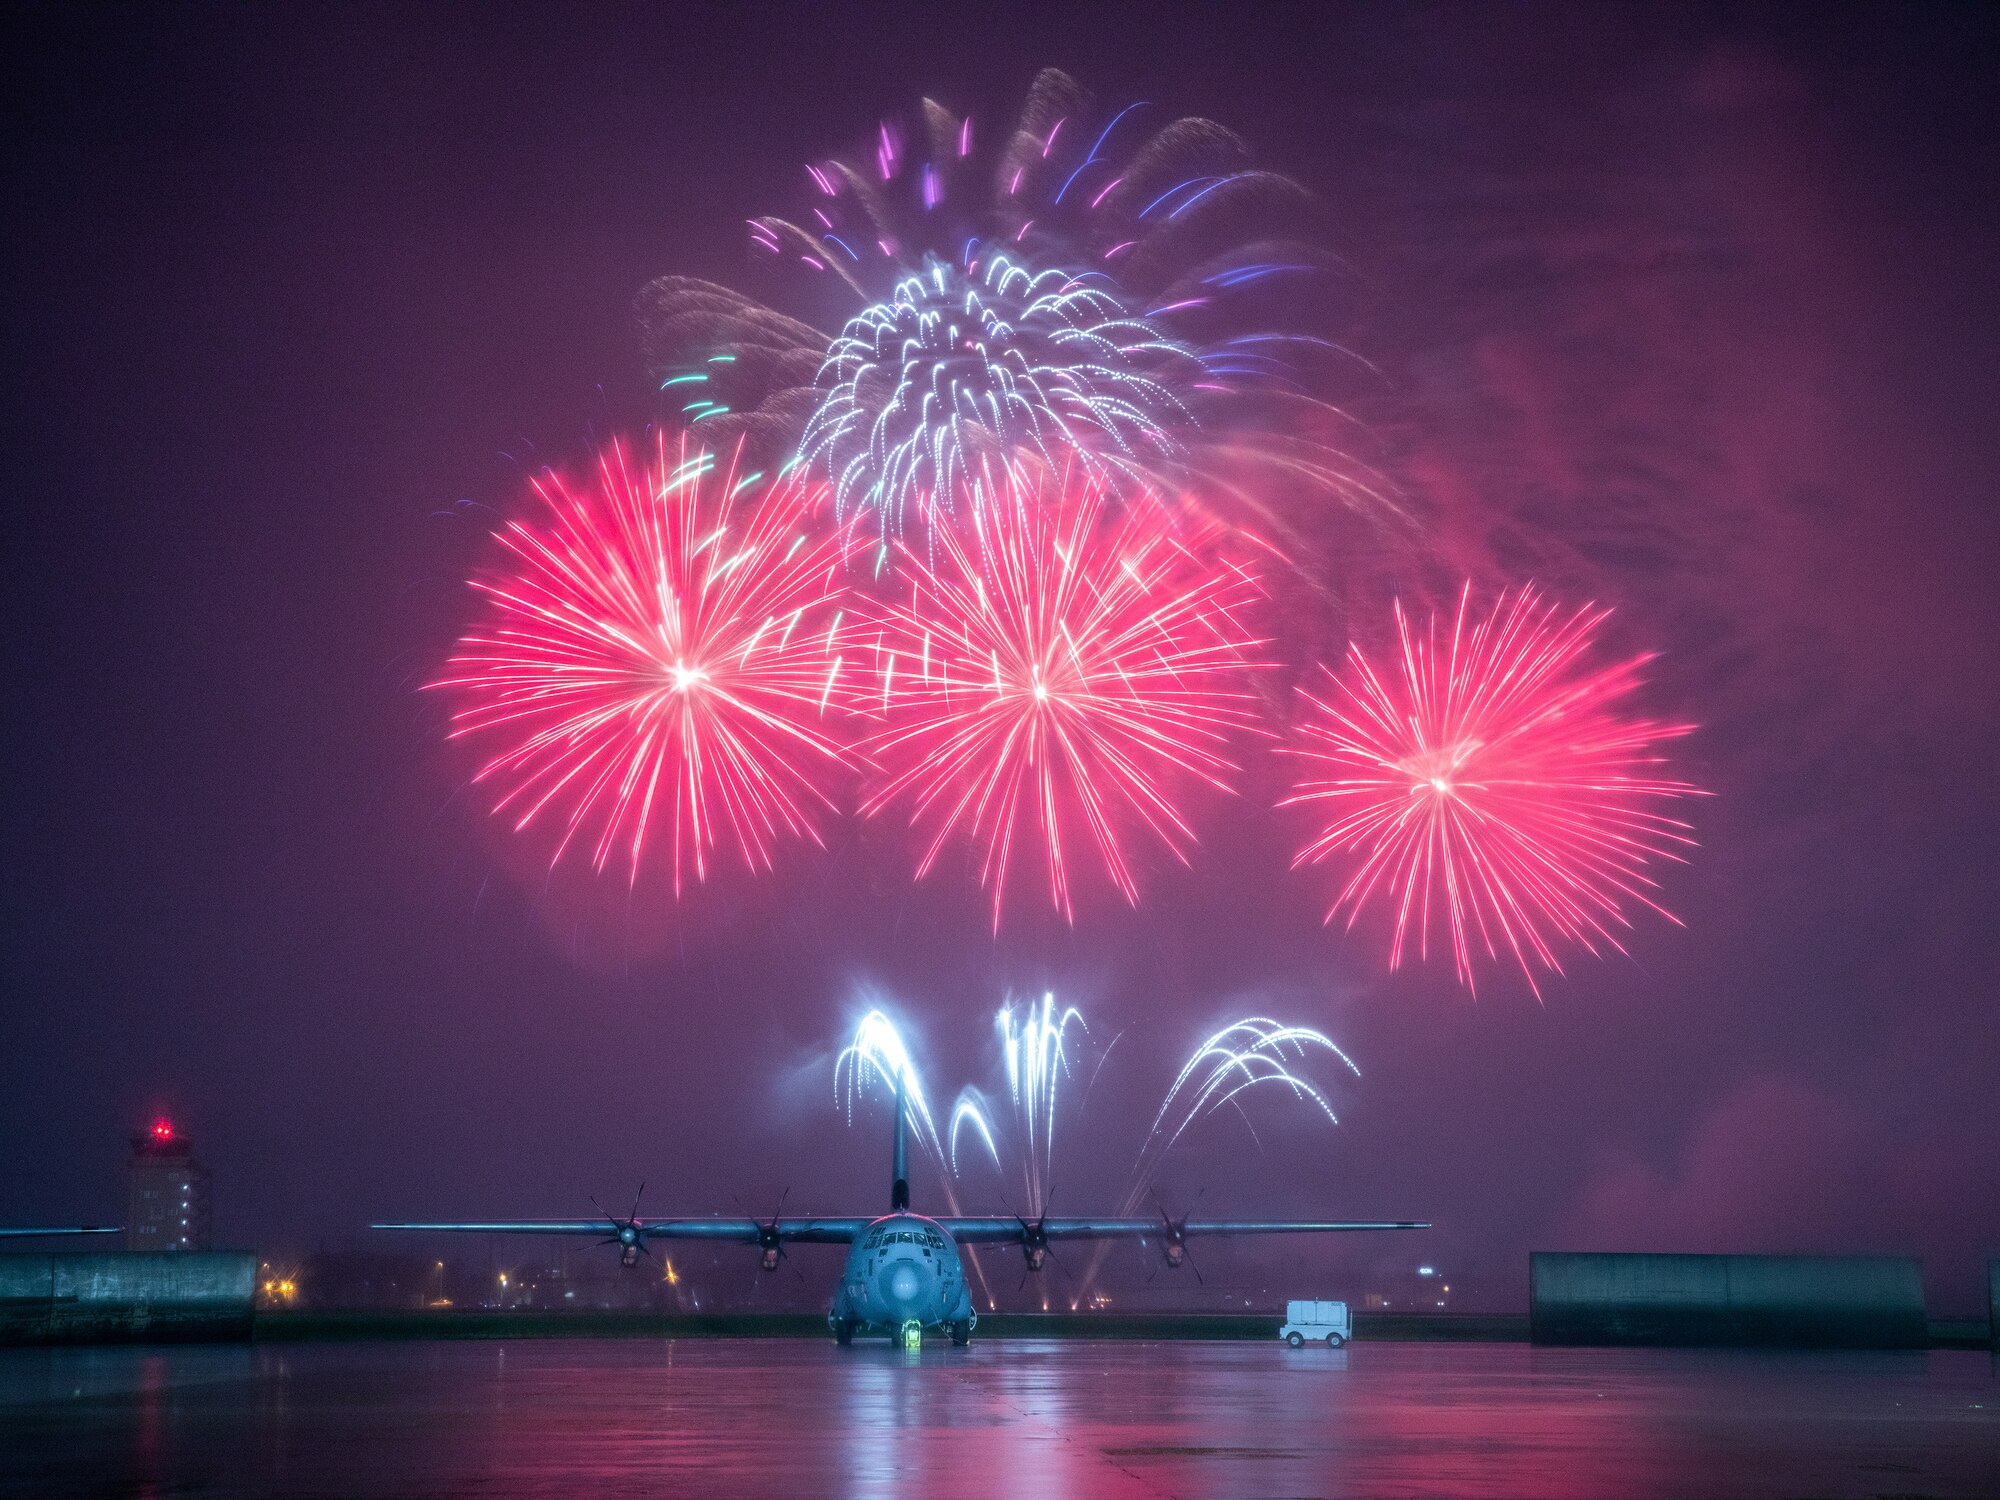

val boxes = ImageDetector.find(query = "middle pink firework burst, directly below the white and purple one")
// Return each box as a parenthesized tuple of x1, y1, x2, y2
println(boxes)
(868, 472, 1262, 930)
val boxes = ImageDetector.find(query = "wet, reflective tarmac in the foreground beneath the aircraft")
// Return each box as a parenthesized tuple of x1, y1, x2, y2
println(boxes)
(0, 1340, 2000, 1500)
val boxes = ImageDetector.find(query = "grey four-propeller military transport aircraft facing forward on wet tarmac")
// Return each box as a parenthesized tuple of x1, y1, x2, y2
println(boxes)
(368, 1088, 1430, 1344)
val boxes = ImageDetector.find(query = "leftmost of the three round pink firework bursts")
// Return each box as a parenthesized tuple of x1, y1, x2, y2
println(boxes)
(430, 436, 852, 896)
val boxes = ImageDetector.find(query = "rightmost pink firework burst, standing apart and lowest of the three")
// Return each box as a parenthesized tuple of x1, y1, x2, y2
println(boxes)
(1286, 588, 1698, 994)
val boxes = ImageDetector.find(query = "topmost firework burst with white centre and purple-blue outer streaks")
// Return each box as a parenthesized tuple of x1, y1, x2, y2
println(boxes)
(638, 70, 1384, 532)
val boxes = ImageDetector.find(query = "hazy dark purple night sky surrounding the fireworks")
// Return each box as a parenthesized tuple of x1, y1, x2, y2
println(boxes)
(0, 4, 2000, 1306)
